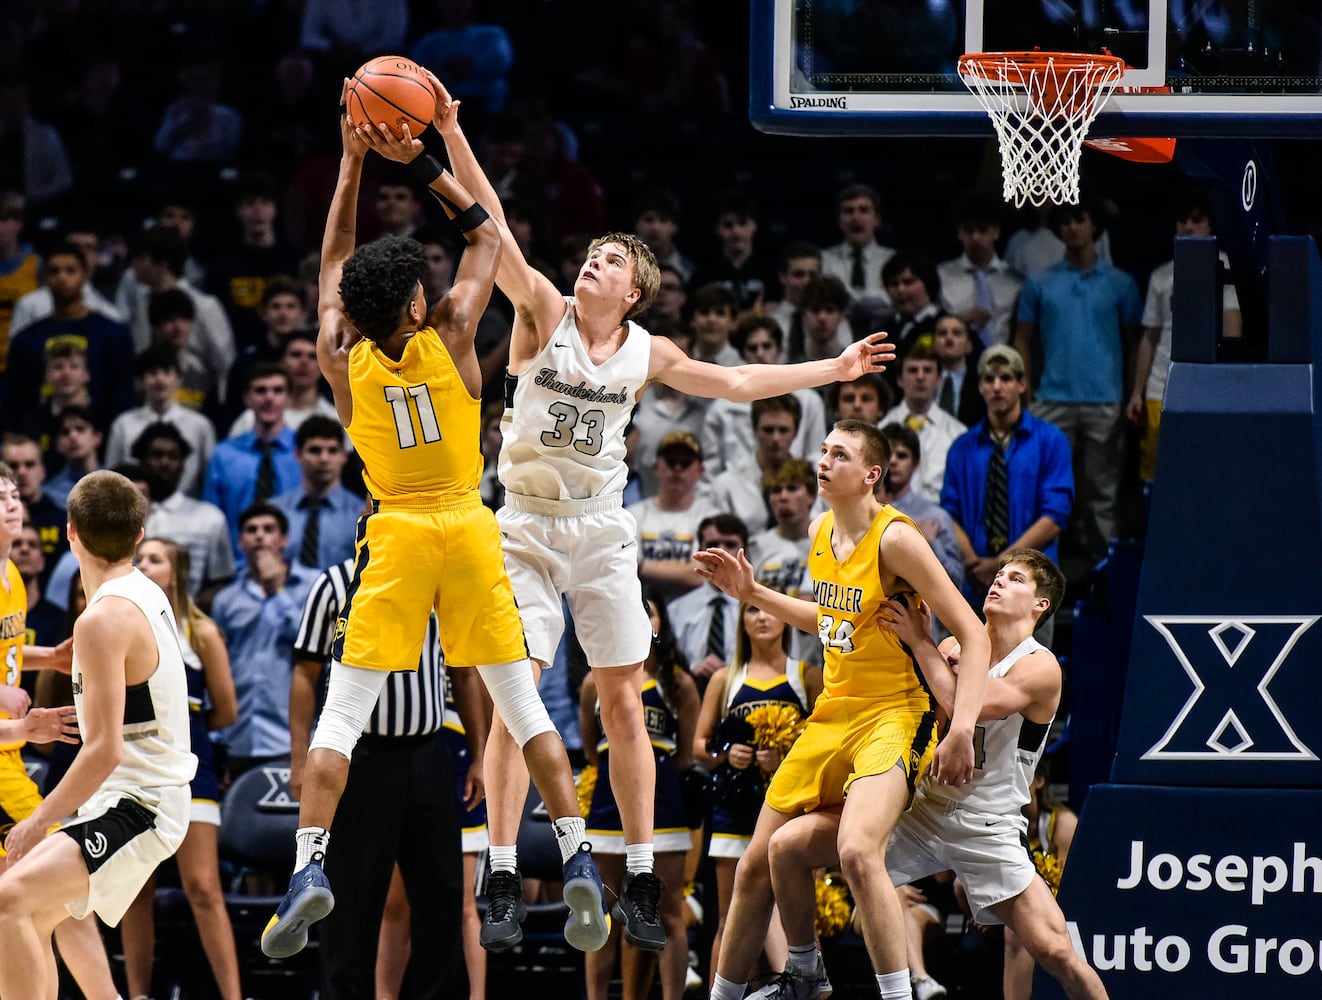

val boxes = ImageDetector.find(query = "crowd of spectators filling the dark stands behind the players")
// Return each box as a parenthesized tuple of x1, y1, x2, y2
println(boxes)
(0, 0, 1258, 996)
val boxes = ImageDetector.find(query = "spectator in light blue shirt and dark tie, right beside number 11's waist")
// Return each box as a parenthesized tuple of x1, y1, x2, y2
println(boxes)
(271, 414, 362, 570)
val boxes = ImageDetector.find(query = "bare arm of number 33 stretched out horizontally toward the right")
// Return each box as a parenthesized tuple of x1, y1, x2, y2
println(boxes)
(648, 332, 895, 402)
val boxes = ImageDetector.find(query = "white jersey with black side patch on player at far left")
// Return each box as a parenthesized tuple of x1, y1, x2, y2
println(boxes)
(73, 569, 197, 796)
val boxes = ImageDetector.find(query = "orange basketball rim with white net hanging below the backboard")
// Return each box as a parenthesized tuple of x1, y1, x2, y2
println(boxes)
(960, 52, 1125, 208)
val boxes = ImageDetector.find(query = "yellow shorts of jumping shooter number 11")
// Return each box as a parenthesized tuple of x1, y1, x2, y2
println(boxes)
(331, 495, 527, 671)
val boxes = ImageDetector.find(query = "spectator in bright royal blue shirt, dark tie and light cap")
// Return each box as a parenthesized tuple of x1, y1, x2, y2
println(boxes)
(941, 344, 1073, 643)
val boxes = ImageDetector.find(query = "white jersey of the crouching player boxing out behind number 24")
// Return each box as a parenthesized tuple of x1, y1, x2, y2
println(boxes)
(923, 635, 1054, 816)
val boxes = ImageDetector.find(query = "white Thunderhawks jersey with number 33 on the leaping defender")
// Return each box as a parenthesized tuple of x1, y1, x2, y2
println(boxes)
(498, 298, 652, 500)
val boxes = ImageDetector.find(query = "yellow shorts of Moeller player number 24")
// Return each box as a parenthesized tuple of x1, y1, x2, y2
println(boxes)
(767, 702, 937, 816)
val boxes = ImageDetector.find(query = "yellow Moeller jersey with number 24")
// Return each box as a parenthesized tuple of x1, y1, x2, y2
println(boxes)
(808, 507, 931, 716)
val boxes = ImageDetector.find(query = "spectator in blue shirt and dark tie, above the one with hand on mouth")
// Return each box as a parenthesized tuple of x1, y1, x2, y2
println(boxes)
(202, 361, 303, 553)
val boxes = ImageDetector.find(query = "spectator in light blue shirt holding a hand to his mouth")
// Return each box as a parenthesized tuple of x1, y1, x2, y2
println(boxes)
(212, 503, 317, 778)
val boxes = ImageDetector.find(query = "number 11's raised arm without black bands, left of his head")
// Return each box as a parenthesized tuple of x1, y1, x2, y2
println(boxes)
(317, 79, 368, 427)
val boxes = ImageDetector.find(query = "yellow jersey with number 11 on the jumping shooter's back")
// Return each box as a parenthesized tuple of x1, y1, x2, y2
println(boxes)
(349, 327, 483, 501)
